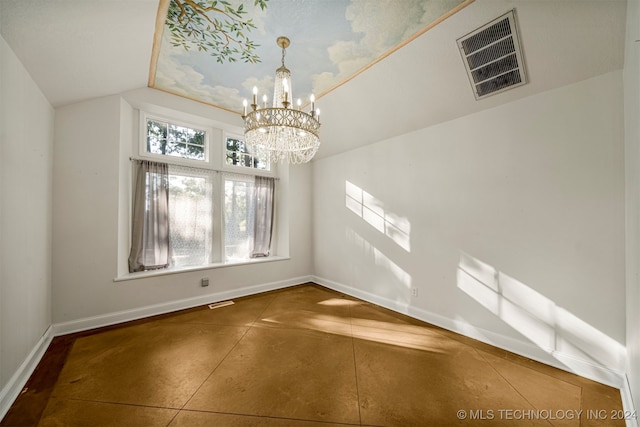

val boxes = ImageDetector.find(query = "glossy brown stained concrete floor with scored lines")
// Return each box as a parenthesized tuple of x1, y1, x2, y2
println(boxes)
(0, 284, 624, 427)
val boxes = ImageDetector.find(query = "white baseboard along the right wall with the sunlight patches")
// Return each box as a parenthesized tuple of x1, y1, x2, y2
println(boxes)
(312, 276, 636, 392)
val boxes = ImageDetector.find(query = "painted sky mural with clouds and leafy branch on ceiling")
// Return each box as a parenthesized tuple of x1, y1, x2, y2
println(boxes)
(149, 0, 468, 112)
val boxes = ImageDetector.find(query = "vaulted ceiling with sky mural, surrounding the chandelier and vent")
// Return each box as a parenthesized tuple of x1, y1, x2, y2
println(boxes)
(0, 0, 626, 157)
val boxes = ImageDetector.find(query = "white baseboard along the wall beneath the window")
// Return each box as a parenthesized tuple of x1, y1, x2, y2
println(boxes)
(53, 276, 311, 336)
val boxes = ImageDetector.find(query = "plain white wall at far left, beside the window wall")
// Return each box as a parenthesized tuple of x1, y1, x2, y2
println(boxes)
(0, 33, 54, 402)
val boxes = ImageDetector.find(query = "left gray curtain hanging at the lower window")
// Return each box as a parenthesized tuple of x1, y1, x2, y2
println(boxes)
(129, 160, 171, 273)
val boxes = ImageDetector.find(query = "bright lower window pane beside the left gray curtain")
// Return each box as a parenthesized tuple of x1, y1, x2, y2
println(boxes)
(169, 173, 212, 267)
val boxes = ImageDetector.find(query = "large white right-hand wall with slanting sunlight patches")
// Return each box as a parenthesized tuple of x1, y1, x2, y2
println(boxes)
(313, 72, 625, 385)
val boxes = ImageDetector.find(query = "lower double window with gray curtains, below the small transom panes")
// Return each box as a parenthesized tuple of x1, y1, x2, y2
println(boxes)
(130, 161, 274, 272)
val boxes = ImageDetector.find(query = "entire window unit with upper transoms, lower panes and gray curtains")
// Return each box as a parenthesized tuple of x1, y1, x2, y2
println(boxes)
(129, 112, 275, 272)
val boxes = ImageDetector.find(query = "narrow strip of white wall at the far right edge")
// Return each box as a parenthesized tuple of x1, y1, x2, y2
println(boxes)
(624, 1, 640, 422)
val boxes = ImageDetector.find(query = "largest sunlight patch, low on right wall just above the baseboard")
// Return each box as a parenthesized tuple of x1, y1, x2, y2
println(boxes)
(457, 254, 625, 374)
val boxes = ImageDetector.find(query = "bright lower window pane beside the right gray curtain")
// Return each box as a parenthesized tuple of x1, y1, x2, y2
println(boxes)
(224, 178, 255, 261)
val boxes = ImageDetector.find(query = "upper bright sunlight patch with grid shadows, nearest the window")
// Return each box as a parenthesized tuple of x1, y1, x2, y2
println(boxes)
(345, 181, 411, 252)
